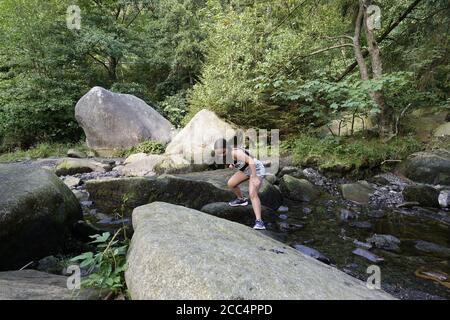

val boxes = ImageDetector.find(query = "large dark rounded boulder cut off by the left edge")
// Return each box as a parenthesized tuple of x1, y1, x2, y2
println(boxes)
(0, 164, 82, 270)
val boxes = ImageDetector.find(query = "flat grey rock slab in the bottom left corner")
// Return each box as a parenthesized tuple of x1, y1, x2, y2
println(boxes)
(0, 270, 99, 300)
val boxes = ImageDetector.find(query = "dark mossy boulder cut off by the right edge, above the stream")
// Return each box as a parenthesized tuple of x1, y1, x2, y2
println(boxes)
(400, 149, 450, 185)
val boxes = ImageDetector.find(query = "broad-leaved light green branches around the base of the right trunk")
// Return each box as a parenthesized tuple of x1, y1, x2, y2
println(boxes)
(273, 72, 433, 132)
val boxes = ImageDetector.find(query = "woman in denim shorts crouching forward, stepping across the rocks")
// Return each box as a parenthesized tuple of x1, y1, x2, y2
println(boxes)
(214, 139, 266, 230)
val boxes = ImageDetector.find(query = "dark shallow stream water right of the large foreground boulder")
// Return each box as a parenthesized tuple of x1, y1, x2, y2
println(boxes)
(268, 201, 450, 299)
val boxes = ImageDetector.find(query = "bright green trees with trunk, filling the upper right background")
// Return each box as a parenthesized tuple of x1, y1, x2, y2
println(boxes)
(190, 0, 449, 137)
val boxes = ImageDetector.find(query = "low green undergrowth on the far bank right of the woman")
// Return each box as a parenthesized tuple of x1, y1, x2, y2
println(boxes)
(282, 134, 423, 173)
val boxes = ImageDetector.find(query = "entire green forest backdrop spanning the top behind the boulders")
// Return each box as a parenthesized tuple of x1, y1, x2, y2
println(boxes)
(0, 0, 450, 152)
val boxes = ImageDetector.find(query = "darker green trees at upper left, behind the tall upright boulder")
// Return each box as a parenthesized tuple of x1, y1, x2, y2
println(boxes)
(0, 0, 204, 149)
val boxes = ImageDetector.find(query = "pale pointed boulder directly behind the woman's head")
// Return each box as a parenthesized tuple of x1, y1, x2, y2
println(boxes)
(166, 109, 238, 164)
